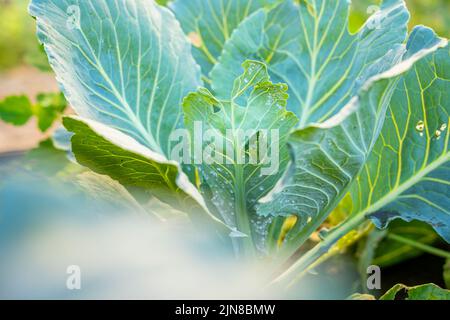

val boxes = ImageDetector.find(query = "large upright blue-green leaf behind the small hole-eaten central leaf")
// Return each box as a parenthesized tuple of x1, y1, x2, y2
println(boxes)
(211, 0, 409, 127)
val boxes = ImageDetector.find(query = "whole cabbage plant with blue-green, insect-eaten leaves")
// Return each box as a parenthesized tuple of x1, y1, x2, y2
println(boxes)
(29, 0, 450, 285)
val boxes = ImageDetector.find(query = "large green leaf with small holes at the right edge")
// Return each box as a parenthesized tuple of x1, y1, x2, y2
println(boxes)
(352, 27, 450, 242)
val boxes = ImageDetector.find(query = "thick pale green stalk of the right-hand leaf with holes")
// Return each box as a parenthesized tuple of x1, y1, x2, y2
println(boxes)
(271, 214, 365, 287)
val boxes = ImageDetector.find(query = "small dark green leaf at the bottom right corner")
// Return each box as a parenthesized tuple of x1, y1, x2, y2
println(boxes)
(380, 283, 450, 300)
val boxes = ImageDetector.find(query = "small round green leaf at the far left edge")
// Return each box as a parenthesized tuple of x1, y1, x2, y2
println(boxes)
(0, 96, 33, 126)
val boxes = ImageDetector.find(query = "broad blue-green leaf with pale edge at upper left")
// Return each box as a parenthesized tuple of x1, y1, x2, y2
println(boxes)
(30, 0, 201, 156)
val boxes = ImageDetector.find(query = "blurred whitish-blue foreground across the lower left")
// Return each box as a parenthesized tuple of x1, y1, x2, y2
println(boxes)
(0, 156, 358, 299)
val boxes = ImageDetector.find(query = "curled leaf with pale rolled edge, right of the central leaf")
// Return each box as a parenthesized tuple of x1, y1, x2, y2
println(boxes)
(258, 28, 442, 255)
